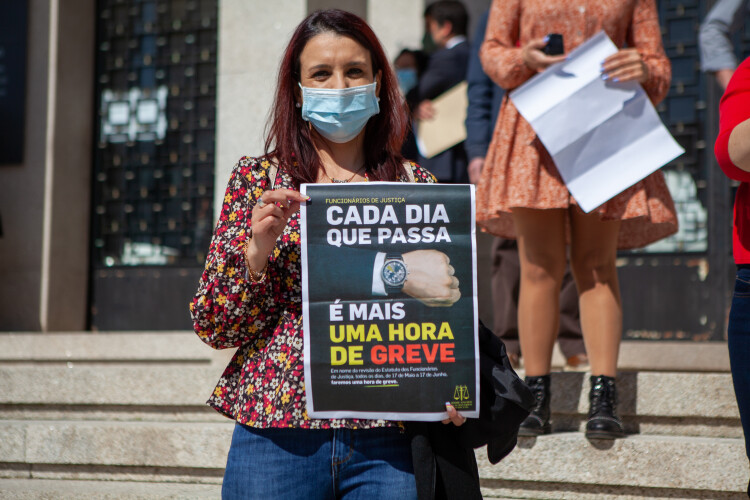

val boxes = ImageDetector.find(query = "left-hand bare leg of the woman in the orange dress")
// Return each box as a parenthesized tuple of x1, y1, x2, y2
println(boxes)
(513, 208, 566, 377)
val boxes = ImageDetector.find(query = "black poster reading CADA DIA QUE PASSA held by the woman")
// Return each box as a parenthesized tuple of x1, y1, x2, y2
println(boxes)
(300, 182, 479, 421)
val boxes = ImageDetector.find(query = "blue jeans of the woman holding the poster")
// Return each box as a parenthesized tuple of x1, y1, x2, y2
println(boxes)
(221, 424, 417, 500)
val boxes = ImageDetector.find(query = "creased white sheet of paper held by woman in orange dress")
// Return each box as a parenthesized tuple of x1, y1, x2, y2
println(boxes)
(510, 31, 685, 212)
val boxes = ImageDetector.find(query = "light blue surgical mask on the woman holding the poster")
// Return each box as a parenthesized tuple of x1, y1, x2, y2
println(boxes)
(300, 82, 380, 144)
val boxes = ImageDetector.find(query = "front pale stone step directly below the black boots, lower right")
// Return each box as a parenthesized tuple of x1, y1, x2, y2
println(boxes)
(477, 432, 750, 499)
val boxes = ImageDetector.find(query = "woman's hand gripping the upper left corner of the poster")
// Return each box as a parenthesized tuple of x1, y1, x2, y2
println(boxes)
(245, 189, 309, 271)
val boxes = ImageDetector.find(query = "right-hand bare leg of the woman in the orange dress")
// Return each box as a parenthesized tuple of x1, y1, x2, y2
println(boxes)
(569, 207, 622, 377)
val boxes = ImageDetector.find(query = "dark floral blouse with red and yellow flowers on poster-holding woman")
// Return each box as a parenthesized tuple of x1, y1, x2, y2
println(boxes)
(190, 157, 436, 429)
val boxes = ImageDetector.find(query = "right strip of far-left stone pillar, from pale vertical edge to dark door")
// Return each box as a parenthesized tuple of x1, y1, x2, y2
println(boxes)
(40, 0, 96, 331)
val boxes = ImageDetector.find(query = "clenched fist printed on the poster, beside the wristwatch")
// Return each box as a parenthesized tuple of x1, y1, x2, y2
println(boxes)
(402, 250, 461, 307)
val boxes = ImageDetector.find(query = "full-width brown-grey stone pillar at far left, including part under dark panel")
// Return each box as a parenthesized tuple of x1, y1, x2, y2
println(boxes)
(0, 0, 95, 331)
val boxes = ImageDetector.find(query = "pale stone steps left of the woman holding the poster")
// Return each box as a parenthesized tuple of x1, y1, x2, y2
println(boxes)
(0, 332, 233, 499)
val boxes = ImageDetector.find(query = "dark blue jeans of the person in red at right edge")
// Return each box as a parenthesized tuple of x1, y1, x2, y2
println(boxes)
(729, 266, 750, 466)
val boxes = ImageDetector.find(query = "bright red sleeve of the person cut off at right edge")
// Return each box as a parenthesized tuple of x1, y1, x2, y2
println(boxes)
(714, 58, 750, 182)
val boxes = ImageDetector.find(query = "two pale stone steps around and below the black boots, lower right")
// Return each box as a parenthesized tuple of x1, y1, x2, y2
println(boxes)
(478, 371, 750, 500)
